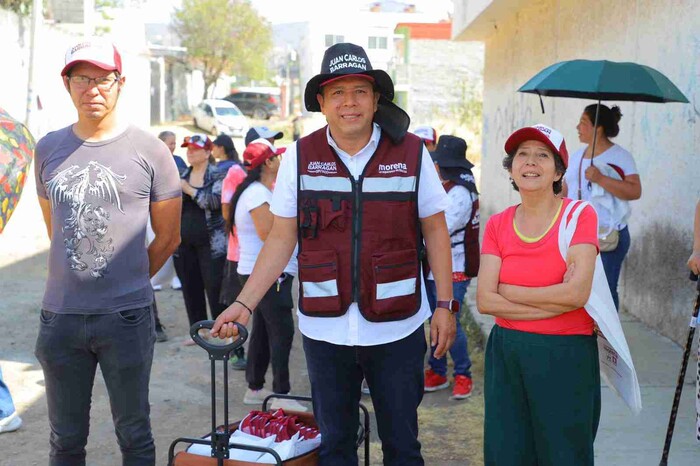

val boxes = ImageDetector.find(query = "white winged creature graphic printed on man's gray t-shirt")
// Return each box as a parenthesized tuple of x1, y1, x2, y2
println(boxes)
(46, 161, 126, 278)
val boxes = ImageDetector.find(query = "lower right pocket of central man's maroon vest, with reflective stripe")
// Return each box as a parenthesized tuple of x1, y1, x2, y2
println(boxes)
(372, 249, 418, 315)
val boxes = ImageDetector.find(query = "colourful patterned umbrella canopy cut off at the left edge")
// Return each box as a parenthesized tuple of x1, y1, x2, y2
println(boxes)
(0, 108, 34, 233)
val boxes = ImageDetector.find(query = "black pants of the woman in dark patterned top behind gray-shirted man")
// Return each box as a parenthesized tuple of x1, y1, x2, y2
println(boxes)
(173, 243, 226, 325)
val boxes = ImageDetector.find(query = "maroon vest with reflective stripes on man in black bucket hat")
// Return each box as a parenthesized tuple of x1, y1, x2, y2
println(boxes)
(297, 127, 423, 322)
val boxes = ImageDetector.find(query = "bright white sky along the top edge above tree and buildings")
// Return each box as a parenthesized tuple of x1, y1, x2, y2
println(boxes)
(143, 0, 452, 24)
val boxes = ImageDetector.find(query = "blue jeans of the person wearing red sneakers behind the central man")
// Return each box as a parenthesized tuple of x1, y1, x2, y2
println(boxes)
(425, 280, 472, 378)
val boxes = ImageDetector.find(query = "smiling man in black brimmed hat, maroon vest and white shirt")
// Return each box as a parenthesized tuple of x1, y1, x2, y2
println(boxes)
(212, 43, 459, 466)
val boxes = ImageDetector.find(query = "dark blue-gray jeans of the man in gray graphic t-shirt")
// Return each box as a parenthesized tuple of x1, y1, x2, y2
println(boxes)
(35, 306, 156, 466)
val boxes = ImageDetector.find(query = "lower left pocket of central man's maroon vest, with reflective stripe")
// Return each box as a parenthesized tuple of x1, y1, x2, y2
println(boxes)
(298, 249, 340, 314)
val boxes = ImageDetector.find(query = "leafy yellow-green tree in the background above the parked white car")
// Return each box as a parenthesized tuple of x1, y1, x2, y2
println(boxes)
(173, 0, 272, 98)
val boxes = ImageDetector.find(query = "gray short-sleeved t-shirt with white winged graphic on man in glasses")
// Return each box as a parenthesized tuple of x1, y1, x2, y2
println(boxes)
(34, 126, 182, 314)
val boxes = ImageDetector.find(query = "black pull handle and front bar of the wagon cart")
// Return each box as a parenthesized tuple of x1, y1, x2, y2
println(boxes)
(168, 320, 282, 466)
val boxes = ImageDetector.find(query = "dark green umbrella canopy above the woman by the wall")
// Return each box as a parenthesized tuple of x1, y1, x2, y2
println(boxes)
(518, 60, 688, 103)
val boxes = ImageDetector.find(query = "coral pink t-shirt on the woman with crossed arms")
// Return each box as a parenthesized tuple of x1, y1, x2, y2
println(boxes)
(481, 199, 598, 335)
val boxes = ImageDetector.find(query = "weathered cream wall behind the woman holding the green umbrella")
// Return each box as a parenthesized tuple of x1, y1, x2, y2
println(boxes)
(453, 0, 700, 341)
